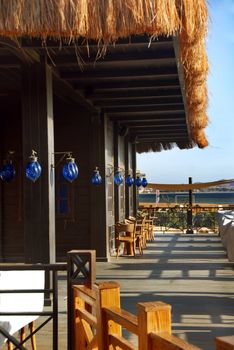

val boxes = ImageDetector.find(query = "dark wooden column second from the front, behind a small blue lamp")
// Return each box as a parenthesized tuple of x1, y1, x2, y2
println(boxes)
(89, 113, 108, 261)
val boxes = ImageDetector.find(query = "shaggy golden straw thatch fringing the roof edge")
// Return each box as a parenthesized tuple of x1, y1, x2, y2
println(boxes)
(0, 0, 208, 150)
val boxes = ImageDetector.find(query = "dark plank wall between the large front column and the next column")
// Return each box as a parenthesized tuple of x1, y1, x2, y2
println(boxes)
(54, 102, 91, 260)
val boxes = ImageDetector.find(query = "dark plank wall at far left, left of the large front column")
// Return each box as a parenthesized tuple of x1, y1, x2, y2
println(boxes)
(0, 95, 25, 262)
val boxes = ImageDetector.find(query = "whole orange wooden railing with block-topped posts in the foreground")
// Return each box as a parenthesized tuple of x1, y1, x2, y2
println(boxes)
(72, 282, 234, 350)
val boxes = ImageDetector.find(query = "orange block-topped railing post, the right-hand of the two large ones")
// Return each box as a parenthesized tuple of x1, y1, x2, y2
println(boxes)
(137, 301, 171, 350)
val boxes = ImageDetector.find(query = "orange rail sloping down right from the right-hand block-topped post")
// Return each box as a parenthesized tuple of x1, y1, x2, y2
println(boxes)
(149, 333, 200, 350)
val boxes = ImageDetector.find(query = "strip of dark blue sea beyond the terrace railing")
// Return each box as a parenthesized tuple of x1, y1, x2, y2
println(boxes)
(139, 191, 234, 204)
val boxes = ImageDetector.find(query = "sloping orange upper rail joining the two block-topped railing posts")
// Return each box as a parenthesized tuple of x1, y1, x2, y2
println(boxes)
(104, 307, 138, 334)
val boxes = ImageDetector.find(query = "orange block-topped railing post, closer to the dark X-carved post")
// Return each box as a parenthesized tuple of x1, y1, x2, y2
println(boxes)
(94, 282, 122, 350)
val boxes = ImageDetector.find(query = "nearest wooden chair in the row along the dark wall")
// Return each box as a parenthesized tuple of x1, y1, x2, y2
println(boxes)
(115, 222, 137, 258)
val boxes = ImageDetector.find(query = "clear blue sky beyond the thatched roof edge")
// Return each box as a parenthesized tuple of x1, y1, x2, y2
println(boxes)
(137, 0, 234, 183)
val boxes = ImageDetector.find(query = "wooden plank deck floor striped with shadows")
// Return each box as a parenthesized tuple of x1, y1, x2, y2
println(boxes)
(4, 234, 234, 350)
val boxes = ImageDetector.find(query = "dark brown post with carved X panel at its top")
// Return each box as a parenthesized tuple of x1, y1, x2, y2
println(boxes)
(67, 250, 96, 350)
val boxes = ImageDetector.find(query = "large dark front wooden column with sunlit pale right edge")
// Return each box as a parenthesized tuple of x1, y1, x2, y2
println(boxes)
(22, 57, 55, 263)
